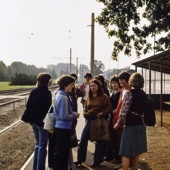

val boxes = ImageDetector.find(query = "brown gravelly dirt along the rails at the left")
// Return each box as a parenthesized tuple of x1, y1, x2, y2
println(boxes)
(0, 102, 35, 170)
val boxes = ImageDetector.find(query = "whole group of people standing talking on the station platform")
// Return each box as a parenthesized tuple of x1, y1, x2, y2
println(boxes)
(26, 72, 147, 170)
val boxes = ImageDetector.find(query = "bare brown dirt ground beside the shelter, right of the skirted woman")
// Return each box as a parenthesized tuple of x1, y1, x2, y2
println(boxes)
(140, 125, 170, 170)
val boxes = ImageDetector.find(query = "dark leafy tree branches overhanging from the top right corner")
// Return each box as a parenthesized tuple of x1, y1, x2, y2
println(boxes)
(96, 0, 170, 60)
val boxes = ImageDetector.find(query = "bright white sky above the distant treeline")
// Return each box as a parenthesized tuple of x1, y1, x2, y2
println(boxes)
(0, 0, 154, 69)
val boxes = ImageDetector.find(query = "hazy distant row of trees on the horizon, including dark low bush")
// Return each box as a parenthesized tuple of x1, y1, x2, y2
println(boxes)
(0, 60, 129, 85)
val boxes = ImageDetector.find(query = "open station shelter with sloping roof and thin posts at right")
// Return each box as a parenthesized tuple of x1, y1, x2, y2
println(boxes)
(132, 50, 170, 126)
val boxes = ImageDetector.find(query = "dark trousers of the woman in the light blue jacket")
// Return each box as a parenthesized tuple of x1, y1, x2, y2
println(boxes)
(53, 128, 70, 170)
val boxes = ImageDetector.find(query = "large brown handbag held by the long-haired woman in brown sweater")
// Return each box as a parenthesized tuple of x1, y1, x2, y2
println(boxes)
(90, 117, 110, 142)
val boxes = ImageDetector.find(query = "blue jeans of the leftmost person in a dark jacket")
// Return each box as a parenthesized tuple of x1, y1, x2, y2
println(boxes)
(31, 123, 48, 170)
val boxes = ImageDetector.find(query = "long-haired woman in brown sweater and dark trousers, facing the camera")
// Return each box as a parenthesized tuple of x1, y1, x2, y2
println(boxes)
(74, 79, 112, 167)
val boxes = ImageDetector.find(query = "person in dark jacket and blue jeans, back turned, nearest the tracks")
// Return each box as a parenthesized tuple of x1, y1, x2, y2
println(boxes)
(26, 73, 52, 170)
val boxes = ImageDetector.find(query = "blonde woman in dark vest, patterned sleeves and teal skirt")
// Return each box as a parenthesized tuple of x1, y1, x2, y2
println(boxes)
(114, 73, 147, 170)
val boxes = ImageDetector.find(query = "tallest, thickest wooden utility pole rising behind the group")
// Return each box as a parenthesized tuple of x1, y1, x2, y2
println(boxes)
(90, 13, 94, 77)
